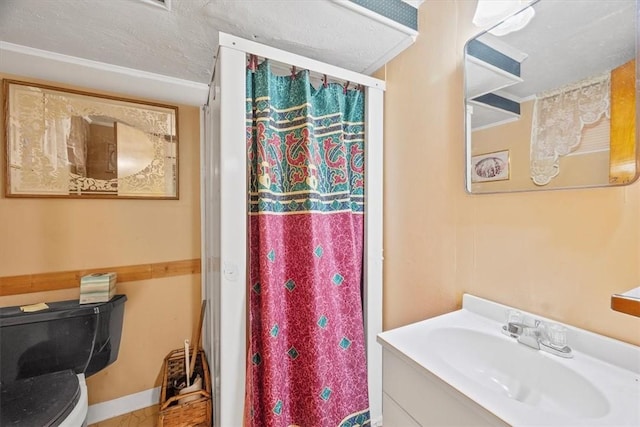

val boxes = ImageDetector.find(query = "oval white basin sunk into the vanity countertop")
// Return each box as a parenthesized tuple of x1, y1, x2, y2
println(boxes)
(426, 327, 609, 418)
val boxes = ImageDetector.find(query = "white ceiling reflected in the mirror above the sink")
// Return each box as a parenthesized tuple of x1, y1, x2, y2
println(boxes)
(480, 0, 637, 100)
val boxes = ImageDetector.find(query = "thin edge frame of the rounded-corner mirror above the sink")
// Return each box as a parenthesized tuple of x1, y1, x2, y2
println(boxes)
(462, 0, 640, 195)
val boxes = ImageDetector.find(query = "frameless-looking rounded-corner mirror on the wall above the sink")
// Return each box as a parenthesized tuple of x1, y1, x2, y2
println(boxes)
(464, 0, 639, 193)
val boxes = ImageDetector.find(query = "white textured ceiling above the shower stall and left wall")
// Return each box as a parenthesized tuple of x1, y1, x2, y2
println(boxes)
(0, 0, 416, 83)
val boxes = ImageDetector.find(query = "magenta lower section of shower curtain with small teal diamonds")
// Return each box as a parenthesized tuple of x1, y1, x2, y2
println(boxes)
(249, 212, 368, 427)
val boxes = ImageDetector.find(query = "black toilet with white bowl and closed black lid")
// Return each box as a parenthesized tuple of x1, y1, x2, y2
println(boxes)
(0, 295, 127, 427)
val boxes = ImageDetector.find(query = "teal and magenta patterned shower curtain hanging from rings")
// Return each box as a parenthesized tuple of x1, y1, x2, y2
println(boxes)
(245, 61, 369, 427)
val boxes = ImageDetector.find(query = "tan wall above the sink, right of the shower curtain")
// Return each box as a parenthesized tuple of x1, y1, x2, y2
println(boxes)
(384, 0, 640, 344)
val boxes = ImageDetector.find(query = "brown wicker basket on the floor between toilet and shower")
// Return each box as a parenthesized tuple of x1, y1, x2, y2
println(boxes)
(158, 349, 212, 427)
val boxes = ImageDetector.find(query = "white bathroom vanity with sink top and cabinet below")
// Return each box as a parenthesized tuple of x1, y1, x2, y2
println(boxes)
(378, 294, 640, 427)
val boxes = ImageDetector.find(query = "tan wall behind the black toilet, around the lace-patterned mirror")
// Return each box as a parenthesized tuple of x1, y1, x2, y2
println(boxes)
(0, 74, 200, 403)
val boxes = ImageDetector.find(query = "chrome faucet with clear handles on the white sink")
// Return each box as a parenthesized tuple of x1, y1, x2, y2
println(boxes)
(502, 312, 573, 358)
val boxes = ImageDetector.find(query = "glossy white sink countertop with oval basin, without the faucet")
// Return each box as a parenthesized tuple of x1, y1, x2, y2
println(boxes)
(378, 295, 640, 427)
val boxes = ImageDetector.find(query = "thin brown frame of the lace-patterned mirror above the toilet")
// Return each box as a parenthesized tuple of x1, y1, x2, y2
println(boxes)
(2, 79, 180, 200)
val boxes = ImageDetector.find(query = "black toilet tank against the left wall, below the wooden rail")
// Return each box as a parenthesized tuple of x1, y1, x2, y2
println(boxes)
(0, 295, 127, 384)
